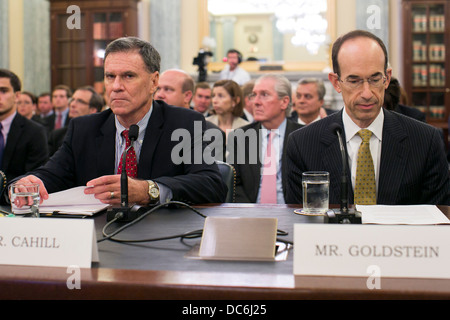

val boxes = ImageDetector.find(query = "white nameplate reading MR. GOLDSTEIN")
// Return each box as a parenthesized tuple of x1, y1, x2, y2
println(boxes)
(294, 224, 450, 279)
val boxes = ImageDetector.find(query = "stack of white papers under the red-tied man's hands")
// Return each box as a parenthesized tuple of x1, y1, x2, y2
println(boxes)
(39, 186, 108, 216)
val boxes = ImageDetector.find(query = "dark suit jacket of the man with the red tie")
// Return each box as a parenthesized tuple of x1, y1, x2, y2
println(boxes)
(22, 101, 227, 203)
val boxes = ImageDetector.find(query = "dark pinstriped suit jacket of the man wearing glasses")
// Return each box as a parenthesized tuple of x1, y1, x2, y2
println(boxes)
(286, 110, 450, 205)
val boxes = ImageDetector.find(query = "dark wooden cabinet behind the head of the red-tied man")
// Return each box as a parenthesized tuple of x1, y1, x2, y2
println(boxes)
(50, 0, 139, 94)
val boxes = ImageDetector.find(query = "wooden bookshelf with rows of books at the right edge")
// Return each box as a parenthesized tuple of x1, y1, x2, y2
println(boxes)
(402, 0, 450, 134)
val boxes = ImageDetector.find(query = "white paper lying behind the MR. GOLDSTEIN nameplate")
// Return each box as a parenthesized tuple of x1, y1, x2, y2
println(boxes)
(356, 205, 450, 225)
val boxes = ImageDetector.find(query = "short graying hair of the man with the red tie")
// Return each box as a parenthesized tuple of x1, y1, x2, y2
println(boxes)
(105, 37, 161, 73)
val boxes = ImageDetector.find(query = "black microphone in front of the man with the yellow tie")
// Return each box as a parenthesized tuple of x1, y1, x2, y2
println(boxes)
(325, 123, 361, 224)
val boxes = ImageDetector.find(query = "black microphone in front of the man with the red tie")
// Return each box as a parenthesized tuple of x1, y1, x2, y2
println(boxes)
(106, 124, 147, 222)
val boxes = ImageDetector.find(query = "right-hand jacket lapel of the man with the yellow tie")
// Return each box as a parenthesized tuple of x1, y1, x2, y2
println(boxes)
(377, 111, 409, 203)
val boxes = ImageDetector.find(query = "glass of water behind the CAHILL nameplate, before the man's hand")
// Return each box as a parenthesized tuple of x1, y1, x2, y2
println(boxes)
(9, 182, 40, 218)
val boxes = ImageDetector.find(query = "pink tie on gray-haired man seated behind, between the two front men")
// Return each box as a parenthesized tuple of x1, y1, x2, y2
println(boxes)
(260, 132, 277, 203)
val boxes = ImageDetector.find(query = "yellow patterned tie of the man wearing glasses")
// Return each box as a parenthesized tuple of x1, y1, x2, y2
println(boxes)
(355, 129, 377, 205)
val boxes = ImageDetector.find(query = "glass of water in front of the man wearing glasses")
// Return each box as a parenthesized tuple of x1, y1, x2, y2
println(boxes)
(302, 171, 330, 215)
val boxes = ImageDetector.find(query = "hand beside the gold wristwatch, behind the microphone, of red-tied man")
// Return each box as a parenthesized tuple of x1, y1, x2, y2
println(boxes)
(84, 174, 148, 204)
